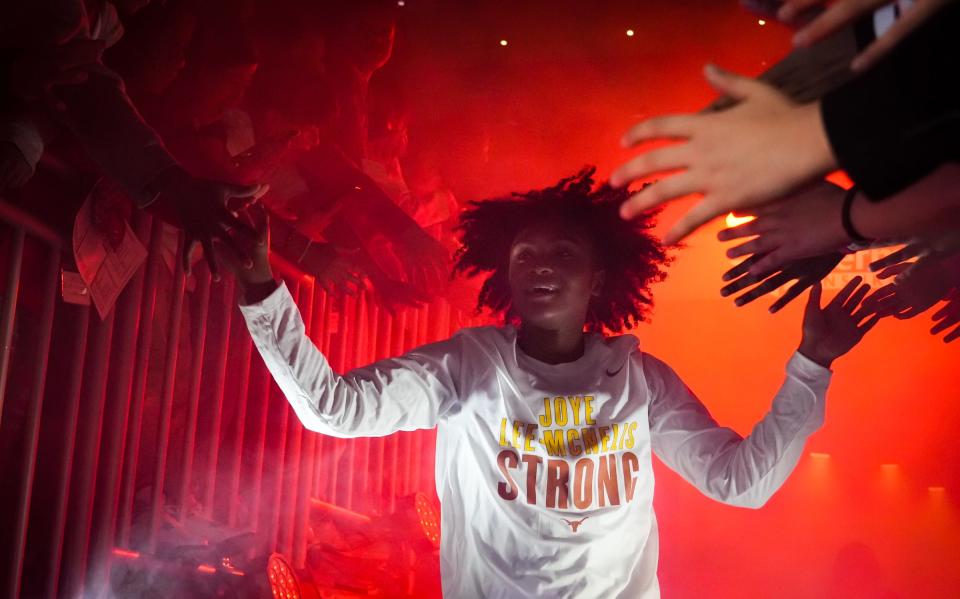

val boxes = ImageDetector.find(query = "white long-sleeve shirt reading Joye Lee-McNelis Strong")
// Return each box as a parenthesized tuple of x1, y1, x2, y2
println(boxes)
(241, 286, 830, 599)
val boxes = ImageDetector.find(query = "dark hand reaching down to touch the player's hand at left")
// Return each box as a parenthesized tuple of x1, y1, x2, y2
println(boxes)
(148, 167, 267, 280)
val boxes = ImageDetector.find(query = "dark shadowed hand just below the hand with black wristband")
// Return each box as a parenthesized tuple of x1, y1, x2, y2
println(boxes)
(720, 252, 843, 313)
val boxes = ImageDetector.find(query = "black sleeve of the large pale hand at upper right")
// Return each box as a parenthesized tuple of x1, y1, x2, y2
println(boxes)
(821, 2, 960, 201)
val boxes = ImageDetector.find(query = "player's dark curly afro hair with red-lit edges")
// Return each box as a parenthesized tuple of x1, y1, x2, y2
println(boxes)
(454, 167, 672, 332)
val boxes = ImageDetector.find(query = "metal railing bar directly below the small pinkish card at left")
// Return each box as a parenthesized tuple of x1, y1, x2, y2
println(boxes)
(44, 306, 93, 599)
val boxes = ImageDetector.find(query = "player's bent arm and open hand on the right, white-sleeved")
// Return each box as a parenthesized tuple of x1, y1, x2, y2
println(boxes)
(641, 279, 876, 508)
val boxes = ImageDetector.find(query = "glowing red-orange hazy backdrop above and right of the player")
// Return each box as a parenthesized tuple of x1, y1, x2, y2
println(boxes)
(397, 1, 960, 598)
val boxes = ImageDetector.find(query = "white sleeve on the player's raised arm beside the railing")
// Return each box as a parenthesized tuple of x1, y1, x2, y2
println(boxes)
(240, 285, 460, 437)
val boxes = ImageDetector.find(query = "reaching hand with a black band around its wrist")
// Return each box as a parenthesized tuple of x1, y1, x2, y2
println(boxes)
(717, 181, 850, 277)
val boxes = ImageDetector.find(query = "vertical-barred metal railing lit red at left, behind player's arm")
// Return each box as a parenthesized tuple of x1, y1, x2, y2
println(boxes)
(0, 201, 480, 599)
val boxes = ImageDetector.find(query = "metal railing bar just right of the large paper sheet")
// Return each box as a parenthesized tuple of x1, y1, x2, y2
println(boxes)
(117, 218, 163, 546)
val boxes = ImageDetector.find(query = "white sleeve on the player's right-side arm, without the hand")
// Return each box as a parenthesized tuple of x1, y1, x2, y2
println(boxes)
(642, 352, 830, 508)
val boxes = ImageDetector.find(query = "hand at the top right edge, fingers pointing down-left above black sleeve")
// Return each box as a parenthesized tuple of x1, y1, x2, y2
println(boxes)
(777, 0, 949, 71)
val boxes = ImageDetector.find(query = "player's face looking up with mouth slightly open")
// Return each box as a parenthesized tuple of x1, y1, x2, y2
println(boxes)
(509, 221, 603, 331)
